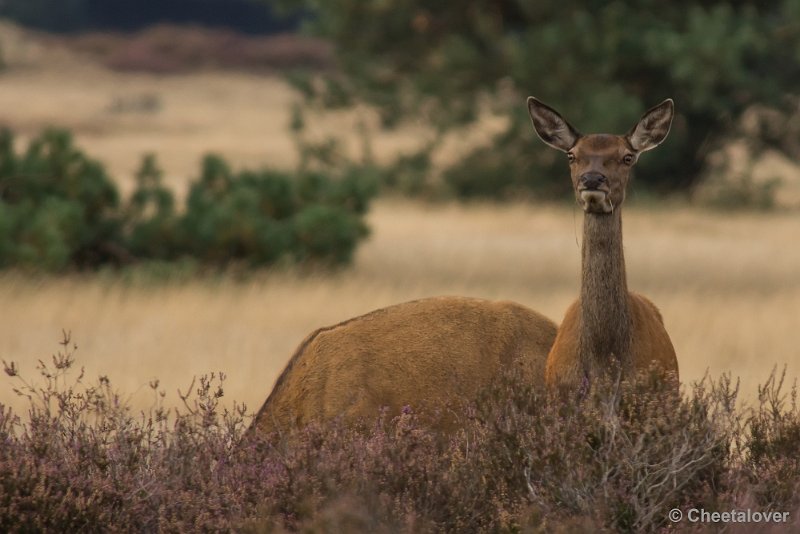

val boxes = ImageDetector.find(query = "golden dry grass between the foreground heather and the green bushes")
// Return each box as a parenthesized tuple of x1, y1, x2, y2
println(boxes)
(0, 201, 800, 416)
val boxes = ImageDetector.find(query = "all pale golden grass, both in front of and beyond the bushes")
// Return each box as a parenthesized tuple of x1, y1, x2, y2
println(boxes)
(0, 23, 800, 418)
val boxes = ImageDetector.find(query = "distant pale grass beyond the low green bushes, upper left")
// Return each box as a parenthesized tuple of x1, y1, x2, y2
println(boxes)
(0, 20, 438, 196)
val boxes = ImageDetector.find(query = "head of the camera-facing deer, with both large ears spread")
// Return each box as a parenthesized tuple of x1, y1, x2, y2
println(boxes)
(528, 96, 674, 213)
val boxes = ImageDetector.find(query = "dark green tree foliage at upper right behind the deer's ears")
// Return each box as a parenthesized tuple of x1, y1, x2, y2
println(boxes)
(283, 0, 800, 197)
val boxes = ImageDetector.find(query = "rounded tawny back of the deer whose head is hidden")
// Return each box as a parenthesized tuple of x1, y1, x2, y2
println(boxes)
(252, 297, 556, 433)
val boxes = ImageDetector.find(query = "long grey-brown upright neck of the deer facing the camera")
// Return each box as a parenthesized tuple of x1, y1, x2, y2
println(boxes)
(579, 208, 631, 373)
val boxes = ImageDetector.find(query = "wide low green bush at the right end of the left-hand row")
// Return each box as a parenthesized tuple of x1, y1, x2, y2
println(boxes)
(179, 156, 376, 266)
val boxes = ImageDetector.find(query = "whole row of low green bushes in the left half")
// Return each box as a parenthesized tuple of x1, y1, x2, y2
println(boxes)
(0, 130, 376, 271)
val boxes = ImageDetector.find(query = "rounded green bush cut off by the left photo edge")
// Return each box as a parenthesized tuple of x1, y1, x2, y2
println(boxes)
(0, 130, 121, 271)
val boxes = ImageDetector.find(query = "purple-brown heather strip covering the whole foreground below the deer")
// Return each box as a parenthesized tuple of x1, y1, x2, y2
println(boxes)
(0, 336, 800, 532)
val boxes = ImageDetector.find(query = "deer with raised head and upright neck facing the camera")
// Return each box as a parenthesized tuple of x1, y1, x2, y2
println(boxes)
(527, 97, 678, 394)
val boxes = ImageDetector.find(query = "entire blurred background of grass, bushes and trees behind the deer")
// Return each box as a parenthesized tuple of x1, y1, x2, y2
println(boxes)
(0, 0, 800, 410)
